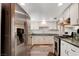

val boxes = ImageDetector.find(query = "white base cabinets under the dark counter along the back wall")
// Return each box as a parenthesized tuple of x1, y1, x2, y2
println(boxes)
(32, 36, 54, 44)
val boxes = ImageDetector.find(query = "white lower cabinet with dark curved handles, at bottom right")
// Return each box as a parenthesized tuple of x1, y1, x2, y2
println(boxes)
(60, 40, 79, 56)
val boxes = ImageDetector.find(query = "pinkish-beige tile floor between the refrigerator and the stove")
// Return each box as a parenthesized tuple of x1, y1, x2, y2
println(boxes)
(31, 45, 53, 56)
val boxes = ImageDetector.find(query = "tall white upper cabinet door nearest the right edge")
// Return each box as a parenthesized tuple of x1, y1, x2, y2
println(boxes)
(69, 4, 78, 25)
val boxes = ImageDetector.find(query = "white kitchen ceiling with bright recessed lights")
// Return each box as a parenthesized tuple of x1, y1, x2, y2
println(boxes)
(19, 3, 70, 21)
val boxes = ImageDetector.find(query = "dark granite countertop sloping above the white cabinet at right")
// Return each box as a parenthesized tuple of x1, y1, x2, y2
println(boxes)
(56, 36, 79, 47)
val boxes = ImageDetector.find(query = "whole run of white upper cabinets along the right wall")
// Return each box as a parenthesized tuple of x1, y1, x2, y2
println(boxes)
(58, 3, 79, 26)
